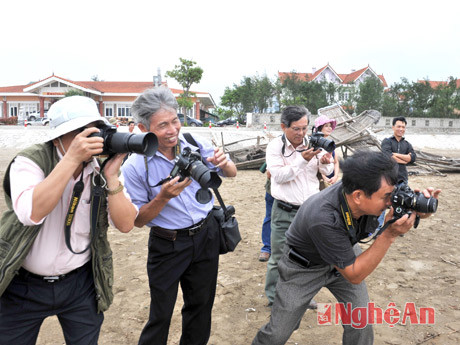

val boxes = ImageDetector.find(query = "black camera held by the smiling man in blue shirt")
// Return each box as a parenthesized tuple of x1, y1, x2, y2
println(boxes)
(169, 147, 222, 204)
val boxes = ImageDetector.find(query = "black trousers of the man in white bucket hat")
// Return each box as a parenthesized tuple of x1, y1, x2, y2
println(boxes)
(0, 265, 104, 345)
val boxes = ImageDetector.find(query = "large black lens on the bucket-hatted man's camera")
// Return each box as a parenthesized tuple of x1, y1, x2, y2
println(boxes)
(107, 132, 158, 156)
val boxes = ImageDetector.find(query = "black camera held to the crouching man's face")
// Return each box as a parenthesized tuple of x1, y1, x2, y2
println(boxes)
(391, 181, 438, 219)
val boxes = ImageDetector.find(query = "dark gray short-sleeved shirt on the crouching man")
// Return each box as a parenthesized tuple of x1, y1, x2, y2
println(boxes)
(286, 182, 378, 268)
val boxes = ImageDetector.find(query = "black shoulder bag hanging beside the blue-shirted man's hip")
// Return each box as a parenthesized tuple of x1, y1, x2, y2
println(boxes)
(212, 188, 241, 254)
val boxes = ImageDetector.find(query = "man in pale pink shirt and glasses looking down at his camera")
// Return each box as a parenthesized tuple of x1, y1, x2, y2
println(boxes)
(265, 106, 334, 307)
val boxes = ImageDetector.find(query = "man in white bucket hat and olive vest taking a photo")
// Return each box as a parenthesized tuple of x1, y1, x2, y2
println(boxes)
(0, 96, 138, 345)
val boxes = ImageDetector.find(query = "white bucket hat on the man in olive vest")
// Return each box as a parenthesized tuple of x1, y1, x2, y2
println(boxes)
(48, 96, 109, 140)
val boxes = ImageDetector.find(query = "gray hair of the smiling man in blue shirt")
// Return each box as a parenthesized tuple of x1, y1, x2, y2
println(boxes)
(131, 86, 179, 130)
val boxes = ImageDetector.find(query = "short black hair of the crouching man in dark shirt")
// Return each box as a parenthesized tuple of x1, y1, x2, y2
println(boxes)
(340, 150, 398, 197)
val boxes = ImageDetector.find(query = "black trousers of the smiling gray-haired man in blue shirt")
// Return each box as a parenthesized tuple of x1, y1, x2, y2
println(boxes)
(139, 217, 219, 345)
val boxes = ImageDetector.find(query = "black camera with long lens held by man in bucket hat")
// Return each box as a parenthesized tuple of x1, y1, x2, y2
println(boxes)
(89, 125, 158, 156)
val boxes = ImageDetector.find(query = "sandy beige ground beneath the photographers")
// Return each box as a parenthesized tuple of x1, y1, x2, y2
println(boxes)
(0, 127, 460, 345)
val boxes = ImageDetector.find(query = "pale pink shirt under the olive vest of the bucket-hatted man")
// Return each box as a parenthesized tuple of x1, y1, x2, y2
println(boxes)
(10, 151, 129, 276)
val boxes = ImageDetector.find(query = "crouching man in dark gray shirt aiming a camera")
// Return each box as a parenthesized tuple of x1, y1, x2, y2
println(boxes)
(252, 151, 441, 345)
